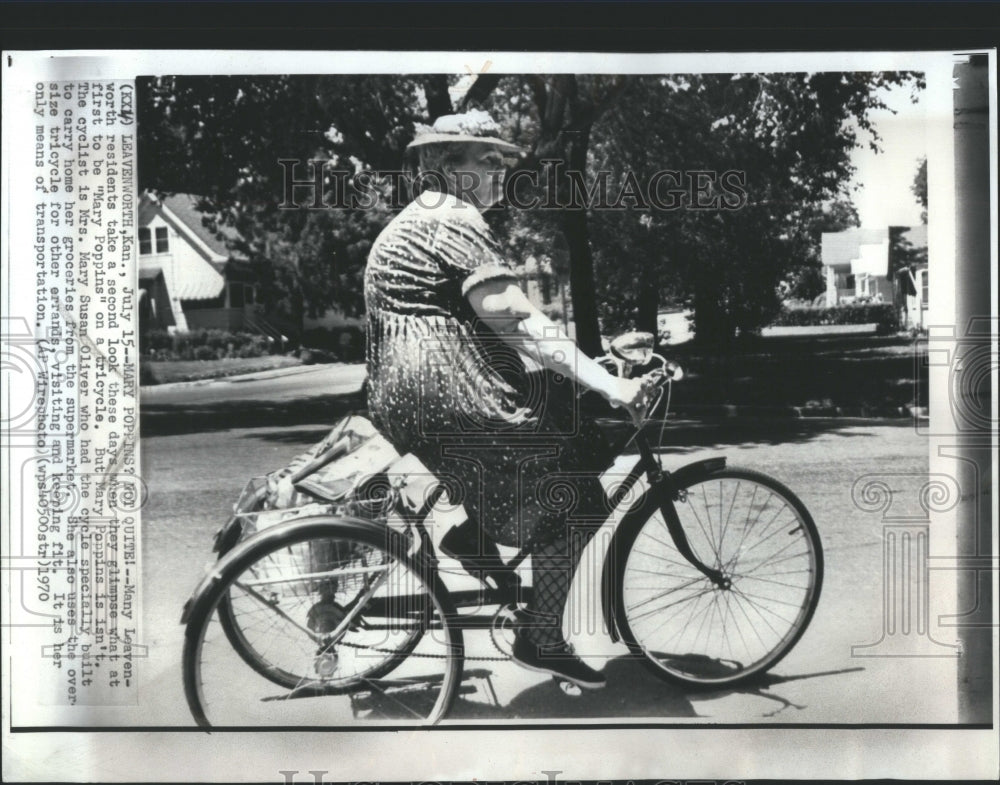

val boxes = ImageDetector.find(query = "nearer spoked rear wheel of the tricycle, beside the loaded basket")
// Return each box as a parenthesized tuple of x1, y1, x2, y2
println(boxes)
(184, 519, 463, 726)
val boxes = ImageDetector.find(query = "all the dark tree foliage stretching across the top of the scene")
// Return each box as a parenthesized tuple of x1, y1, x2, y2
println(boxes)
(139, 72, 926, 353)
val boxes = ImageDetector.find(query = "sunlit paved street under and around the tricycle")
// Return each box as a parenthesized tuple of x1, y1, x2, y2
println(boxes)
(135, 366, 957, 725)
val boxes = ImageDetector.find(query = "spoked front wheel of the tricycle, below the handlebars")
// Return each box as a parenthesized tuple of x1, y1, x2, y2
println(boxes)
(612, 467, 823, 688)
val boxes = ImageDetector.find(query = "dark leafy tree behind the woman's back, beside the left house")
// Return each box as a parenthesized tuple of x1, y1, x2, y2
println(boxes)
(139, 75, 438, 329)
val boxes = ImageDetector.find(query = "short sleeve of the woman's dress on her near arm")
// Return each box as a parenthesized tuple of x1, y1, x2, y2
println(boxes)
(432, 194, 517, 296)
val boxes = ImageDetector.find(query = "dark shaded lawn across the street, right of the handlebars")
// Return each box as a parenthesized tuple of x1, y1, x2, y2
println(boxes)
(665, 335, 927, 409)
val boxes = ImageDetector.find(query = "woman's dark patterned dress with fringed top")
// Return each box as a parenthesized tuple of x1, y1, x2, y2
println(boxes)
(365, 192, 612, 546)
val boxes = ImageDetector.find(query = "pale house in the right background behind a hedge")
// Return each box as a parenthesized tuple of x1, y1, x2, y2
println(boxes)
(822, 226, 927, 327)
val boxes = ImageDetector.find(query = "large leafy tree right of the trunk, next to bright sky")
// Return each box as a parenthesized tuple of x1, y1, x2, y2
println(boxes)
(594, 73, 921, 346)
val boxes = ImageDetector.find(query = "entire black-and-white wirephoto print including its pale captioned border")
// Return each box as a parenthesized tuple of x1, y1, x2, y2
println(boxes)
(4, 35, 996, 782)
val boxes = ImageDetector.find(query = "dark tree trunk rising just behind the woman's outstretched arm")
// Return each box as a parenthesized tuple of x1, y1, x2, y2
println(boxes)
(562, 125, 601, 357)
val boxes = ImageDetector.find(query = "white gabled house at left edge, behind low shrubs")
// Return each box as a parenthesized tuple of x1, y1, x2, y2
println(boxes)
(138, 193, 272, 334)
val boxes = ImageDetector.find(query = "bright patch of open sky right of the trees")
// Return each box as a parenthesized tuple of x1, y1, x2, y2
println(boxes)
(852, 86, 927, 228)
